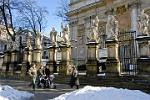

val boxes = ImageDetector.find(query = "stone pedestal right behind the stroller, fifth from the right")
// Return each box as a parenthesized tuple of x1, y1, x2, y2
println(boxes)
(47, 46, 57, 73)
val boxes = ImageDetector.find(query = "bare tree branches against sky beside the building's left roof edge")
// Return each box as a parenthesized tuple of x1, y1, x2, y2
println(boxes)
(56, 0, 69, 21)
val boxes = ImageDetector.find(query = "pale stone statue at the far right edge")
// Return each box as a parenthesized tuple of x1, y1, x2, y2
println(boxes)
(138, 10, 149, 35)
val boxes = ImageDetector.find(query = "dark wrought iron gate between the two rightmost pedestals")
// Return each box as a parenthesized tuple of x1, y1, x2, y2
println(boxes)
(118, 31, 137, 75)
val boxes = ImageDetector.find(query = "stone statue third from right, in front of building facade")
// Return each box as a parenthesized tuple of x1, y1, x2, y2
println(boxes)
(88, 16, 99, 43)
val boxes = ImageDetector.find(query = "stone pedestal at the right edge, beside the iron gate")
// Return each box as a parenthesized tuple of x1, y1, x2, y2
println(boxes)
(136, 36, 150, 75)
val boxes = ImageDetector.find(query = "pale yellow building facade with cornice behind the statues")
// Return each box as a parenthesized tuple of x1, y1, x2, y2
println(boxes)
(68, 0, 150, 65)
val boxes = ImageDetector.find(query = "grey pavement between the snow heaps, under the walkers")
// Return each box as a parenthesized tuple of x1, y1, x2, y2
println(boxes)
(0, 79, 79, 100)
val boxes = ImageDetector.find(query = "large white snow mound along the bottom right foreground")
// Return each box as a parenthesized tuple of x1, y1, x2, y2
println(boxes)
(52, 86, 150, 100)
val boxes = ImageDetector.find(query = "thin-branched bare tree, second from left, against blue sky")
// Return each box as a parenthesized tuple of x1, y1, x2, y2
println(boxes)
(18, 0, 48, 35)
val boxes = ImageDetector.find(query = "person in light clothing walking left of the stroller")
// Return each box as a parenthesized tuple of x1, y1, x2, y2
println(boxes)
(28, 63, 37, 90)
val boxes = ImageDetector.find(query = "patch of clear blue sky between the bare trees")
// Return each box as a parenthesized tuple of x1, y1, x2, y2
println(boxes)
(38, 0, 62, 36)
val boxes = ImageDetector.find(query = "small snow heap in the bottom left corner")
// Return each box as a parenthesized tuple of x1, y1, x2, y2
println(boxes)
(0, 85, 34, 100)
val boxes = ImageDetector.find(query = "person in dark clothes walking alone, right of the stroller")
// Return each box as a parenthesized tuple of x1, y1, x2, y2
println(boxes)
(70, 66, 79, 89)
